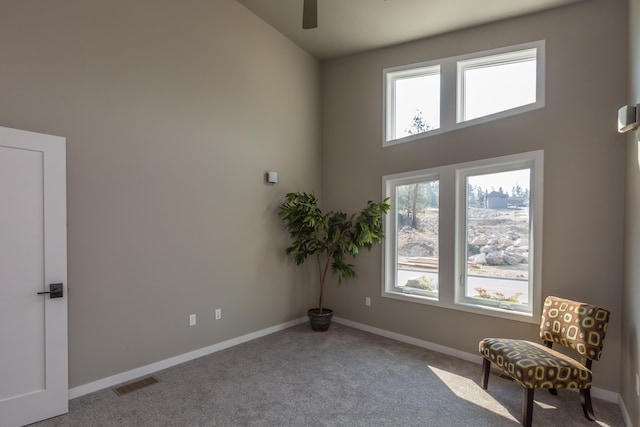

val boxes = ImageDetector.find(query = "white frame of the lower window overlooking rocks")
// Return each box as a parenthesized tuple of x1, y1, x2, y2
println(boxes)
(382, 150, 544, 324)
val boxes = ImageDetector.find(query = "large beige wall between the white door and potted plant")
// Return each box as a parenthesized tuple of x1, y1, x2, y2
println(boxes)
(0, 0, 320, 387)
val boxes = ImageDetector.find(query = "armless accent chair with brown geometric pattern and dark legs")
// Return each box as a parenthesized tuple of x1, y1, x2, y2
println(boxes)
(479, 296, 609, 427)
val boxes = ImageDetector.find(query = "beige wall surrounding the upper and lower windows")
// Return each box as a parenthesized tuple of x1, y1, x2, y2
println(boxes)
(322, 0, 627, 392)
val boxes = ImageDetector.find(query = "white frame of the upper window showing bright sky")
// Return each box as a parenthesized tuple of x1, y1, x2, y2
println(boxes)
(382, 40, 546, 147)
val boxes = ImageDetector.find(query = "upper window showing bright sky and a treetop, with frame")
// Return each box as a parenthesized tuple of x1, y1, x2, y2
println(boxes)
(383, 41, 545, 146)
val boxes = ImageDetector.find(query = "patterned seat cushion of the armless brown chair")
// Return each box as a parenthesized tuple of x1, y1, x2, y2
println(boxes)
(479, 338, 591, 388)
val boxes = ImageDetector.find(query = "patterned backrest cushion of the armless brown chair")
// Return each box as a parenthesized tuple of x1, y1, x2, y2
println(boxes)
(540, 296, 609, 360)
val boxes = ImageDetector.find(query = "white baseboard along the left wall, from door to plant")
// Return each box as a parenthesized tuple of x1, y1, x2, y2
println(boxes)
(69, 316, 308, 399)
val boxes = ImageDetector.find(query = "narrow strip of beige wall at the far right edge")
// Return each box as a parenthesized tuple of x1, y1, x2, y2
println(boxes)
(620, 0, 640, 426)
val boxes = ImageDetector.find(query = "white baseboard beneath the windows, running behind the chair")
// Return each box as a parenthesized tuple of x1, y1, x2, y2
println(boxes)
(333, 316, 630, 404)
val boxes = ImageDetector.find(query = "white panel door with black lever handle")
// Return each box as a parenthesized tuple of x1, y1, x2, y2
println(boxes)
(0, 127, 69, 426)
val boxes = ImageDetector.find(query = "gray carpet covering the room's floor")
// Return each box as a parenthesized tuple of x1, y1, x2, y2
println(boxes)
(31, 323, 624, 427)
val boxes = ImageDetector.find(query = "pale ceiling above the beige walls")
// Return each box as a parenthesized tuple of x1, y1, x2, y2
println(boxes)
(237, 0, 584, 60)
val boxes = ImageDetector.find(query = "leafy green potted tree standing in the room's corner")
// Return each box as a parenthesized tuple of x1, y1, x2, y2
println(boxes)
(278, 192, 391, 331)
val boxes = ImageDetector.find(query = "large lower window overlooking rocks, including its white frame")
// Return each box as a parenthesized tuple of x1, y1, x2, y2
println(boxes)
(383, 151, 543, 322)
